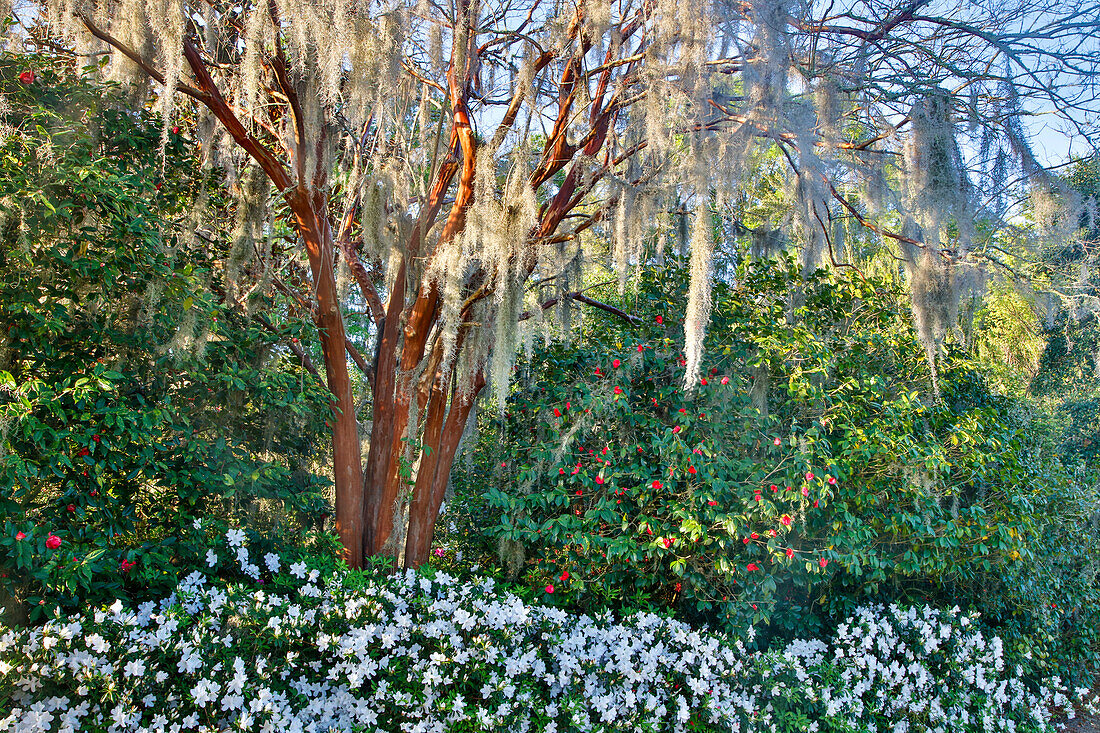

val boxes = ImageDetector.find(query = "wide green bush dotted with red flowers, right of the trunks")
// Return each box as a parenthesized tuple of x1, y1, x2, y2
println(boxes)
(484, 256, 1095, 651)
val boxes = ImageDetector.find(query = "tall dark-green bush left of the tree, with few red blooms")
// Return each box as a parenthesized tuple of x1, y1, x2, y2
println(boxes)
(0, 56, 327, 619)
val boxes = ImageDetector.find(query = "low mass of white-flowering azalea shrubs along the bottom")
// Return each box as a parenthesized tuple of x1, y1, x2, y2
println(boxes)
(0, 535, 1086, 733)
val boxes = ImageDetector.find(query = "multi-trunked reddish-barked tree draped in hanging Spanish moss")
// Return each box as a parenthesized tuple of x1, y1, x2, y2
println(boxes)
(34, 0, 1098, 566)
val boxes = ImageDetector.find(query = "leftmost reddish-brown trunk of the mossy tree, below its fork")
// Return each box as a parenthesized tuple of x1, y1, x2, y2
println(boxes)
(287, 189, 363, 568)
